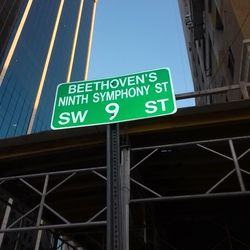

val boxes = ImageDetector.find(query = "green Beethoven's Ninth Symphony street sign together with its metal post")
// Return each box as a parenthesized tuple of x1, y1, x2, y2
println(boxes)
(51, 68, 176, 250)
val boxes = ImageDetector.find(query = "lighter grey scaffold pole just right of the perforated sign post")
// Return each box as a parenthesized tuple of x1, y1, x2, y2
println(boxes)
(120, 148, 130, 250)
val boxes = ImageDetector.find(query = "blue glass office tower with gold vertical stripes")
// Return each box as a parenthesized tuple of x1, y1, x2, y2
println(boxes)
(0, 0, 96, 138)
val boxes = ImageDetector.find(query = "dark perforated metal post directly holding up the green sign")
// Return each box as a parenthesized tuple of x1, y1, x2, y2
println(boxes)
(107, 124, 123, 250)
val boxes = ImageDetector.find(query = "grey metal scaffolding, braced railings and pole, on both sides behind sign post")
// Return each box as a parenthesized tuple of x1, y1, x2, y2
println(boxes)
(0, 133, 250, 249)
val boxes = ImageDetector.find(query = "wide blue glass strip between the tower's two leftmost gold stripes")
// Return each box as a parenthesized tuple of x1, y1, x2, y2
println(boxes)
(0, 0, 60, 136)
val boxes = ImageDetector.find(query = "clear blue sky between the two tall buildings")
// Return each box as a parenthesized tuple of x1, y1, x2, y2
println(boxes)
(88, 0, 193, 106)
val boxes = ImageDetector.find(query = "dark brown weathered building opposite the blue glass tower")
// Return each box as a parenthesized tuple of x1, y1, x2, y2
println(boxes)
(179, 0, 250, 105)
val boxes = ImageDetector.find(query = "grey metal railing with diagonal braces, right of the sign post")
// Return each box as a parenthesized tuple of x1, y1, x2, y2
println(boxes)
(130, 136, 250, 203)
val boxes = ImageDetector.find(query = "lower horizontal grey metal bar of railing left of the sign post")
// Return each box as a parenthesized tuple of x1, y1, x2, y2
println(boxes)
(0, 221, 106, 233)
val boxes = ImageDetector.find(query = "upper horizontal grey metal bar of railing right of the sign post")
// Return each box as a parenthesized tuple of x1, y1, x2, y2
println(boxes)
(131, 135, 250, 151)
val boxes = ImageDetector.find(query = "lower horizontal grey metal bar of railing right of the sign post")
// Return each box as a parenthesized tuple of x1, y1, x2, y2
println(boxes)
(130, 191, 250, 204)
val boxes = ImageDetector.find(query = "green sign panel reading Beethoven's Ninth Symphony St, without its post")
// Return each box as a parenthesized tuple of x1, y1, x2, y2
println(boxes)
(51, 68, 176, 129)
